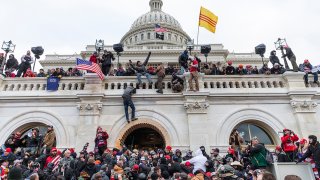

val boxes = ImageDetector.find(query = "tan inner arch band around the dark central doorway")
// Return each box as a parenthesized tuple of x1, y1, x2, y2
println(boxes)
(114, 119, 171, 148)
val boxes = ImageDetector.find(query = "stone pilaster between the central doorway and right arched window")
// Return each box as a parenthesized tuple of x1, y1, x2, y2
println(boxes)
(184, 92, 210, 153)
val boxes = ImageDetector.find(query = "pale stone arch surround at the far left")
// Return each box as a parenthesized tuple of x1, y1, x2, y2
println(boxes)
(0, 111, 70, 148)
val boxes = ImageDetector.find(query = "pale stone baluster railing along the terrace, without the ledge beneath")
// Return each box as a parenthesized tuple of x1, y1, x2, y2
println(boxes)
(0, 73, 318, 94)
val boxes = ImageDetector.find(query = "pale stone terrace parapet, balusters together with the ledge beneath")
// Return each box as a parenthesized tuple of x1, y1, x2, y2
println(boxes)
(0, 72, 320, 96)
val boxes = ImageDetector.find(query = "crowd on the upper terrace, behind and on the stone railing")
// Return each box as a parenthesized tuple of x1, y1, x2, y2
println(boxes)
(0, 46, 320, 88)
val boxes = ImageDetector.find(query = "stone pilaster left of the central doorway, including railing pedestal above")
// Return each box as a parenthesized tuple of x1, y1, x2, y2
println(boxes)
(75, 74, 104, 151)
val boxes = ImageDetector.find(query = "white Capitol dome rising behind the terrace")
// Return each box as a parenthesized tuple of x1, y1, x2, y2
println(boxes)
(121, 0, 190, 46)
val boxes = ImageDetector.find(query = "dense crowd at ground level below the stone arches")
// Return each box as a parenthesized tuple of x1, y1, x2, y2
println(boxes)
(0, 126, 320, 180)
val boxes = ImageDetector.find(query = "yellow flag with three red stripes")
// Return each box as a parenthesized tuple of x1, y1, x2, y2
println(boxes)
(199, 7, 218, 33)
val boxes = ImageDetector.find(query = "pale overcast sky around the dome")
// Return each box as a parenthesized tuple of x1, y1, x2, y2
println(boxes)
(0, 0, 320, 70)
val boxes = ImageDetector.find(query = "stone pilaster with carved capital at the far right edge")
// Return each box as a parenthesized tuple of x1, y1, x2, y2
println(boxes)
(290, 91, 320, 138)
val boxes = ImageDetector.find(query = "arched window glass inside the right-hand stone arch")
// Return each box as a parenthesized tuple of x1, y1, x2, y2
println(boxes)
(235, 123, 274, 145)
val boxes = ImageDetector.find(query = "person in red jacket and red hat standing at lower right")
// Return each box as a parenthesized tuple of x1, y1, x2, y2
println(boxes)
(281, 129, 299, 162)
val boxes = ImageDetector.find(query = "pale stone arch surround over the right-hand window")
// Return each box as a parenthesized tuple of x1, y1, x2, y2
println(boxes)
(216, 109, 285, 146)
